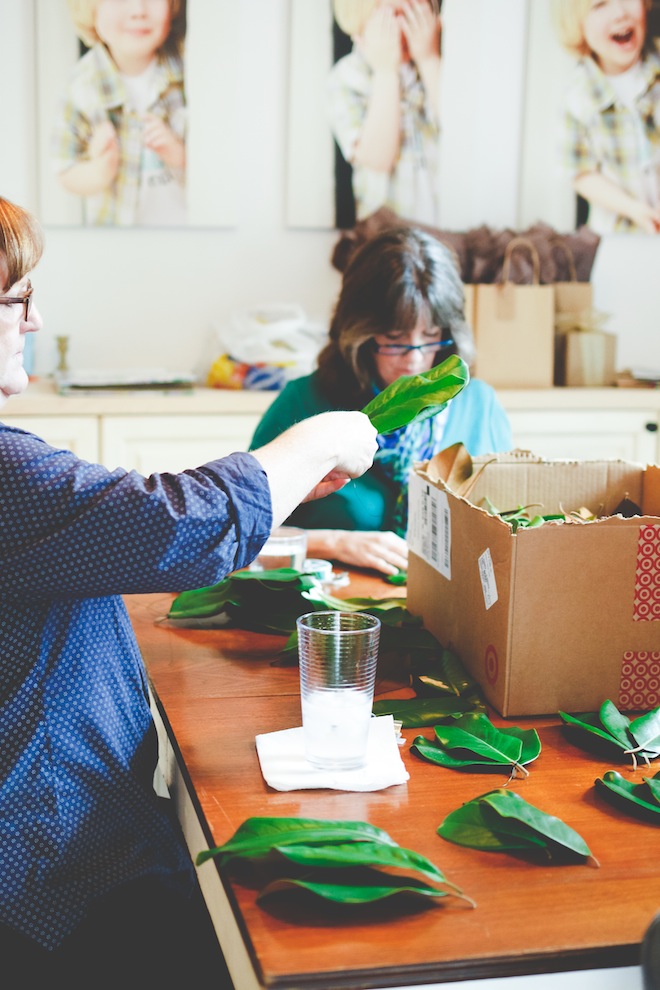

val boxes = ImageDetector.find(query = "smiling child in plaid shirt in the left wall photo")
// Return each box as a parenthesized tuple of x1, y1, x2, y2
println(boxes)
(51, 0, 187, 227)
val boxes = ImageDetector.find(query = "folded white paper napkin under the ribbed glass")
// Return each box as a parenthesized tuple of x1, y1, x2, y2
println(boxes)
(255, 715, 410, 791)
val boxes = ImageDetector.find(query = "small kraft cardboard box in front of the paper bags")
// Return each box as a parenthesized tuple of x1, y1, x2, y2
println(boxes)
(555, 330, 616, 387)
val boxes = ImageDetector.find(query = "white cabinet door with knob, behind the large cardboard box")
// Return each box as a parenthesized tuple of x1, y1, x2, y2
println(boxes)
(502, 409, 658, 464)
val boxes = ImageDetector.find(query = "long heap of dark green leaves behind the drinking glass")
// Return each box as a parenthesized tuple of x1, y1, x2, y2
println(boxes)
(167, 568, 485, 716)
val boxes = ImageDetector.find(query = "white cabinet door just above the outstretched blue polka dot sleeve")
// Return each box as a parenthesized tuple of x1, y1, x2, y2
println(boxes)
(101, 413, 260, 475)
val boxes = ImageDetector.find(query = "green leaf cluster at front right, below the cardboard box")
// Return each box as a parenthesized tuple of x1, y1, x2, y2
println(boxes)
(438, 788, 600, 866)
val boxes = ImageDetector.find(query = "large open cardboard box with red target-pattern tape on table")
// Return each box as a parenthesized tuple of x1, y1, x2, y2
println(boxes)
(408, 451, 660, 717)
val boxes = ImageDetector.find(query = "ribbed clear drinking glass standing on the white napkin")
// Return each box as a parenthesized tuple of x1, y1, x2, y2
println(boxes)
(296, 611, 380, 770)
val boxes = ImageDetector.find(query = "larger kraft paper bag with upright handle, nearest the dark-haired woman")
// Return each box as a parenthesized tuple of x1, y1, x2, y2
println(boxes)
(472, 237, 555, 388)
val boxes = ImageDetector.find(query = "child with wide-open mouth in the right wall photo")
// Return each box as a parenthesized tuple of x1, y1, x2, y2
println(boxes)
(553, 0, 660, 234)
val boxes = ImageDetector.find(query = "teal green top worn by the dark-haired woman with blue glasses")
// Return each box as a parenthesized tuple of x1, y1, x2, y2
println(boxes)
(250, 372, 513, 530)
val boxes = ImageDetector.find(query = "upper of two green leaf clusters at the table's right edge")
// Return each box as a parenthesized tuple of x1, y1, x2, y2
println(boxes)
(559, 700, 660, 770)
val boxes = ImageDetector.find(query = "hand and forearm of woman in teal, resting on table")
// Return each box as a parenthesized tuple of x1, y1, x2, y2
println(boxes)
(307, 529, 408, 574)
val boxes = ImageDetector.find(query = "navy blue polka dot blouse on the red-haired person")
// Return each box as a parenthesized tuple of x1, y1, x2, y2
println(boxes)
(0, 424, 272, 948)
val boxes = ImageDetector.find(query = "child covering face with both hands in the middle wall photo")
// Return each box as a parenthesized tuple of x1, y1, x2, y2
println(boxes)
(327, 0, 441, 224)
